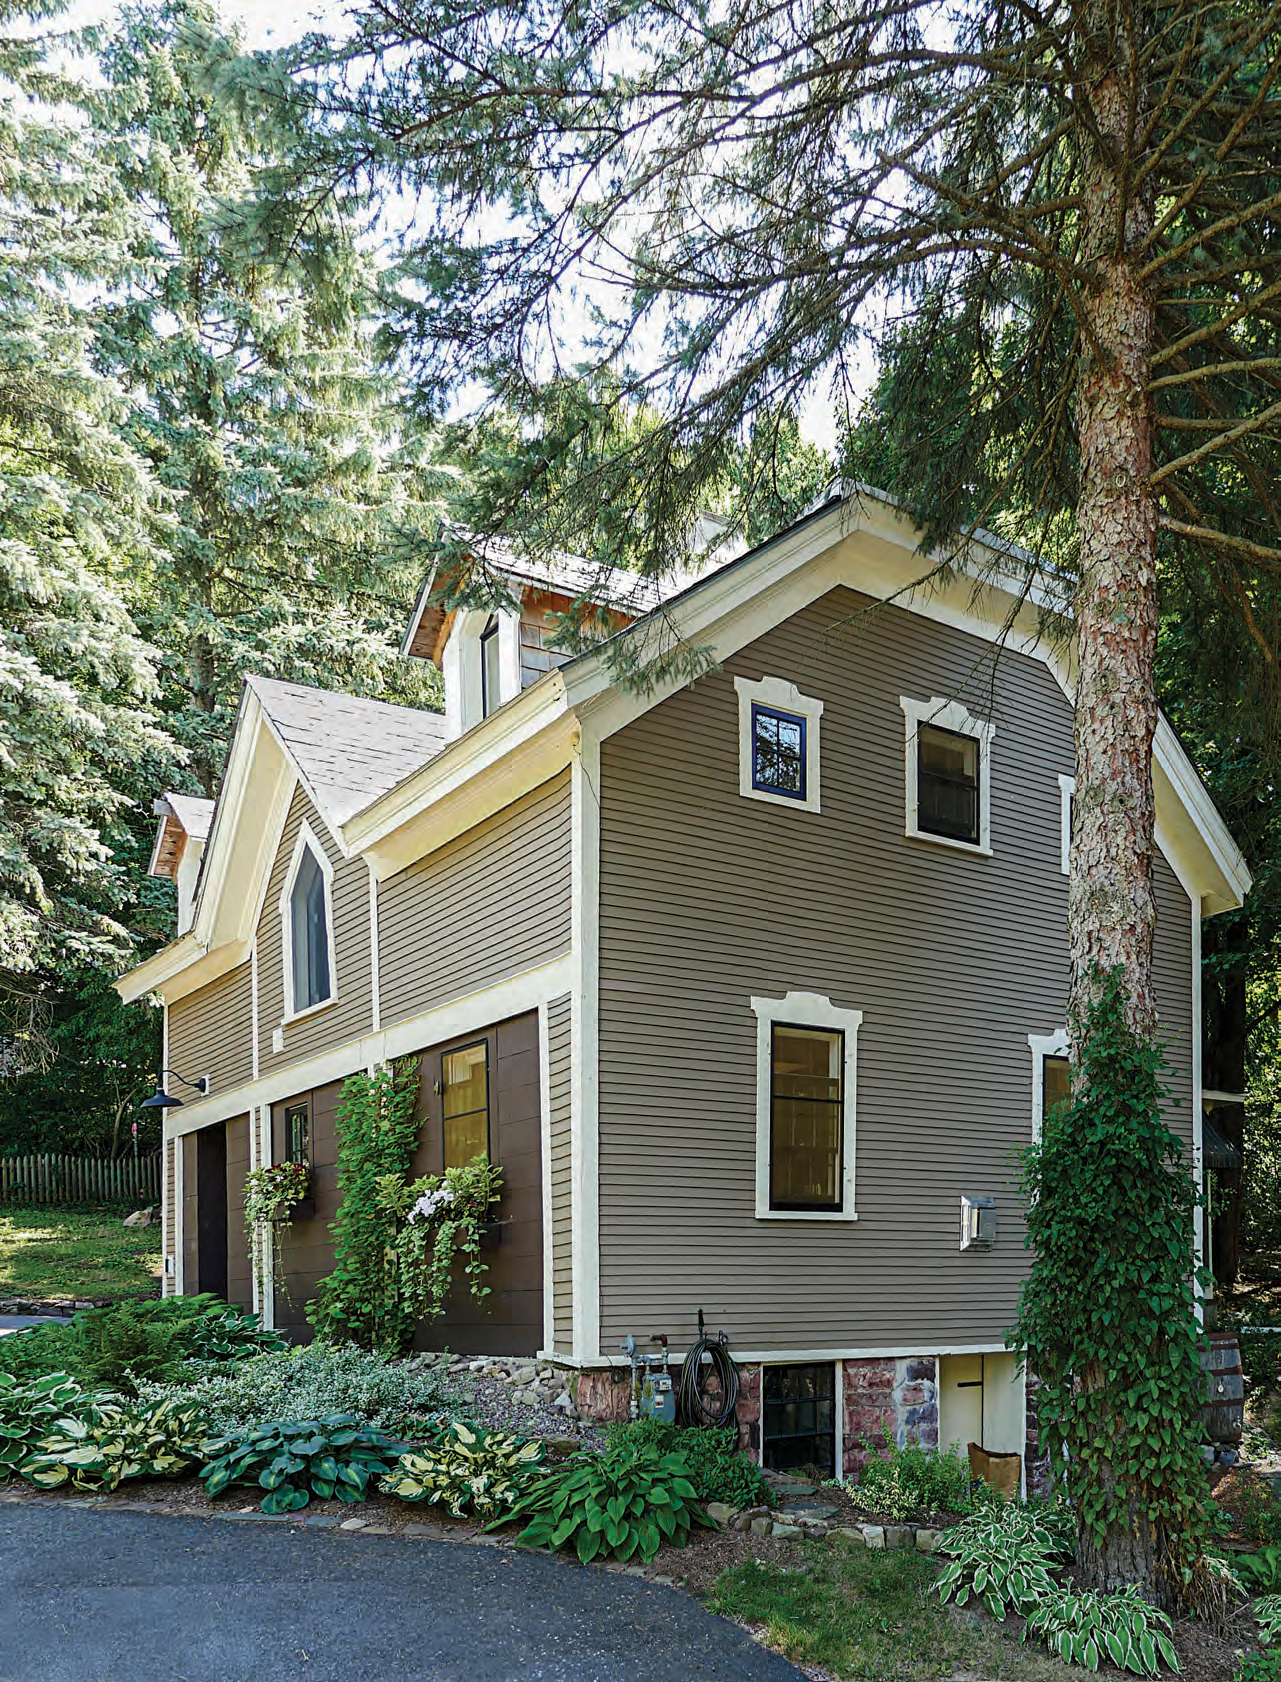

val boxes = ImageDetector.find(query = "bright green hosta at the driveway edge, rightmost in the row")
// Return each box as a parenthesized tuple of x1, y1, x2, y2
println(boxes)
(511, 1443, 711, 1564)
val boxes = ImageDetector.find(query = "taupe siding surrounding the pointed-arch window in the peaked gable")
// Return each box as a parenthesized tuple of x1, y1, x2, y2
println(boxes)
(257, 787, 373, 1075)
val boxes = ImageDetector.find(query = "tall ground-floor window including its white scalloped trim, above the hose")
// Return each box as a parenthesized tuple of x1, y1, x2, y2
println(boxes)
(751, 992, 862, 1221)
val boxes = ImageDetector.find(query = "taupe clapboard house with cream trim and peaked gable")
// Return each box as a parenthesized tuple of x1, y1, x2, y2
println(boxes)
(118, 491, 1249, 1467)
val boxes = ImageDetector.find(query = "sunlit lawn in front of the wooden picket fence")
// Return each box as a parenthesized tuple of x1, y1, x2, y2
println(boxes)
(0, 1208, 160, 1297)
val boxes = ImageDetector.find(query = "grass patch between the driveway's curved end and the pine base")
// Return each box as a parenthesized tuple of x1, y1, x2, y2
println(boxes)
(708, 1542, 1064, 1682)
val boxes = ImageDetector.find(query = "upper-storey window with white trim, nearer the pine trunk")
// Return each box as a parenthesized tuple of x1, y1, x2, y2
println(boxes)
(899, 695, 997, 854)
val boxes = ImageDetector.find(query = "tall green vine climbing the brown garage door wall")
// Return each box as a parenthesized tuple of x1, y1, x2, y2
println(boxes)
(308, 1058, 419, 1354)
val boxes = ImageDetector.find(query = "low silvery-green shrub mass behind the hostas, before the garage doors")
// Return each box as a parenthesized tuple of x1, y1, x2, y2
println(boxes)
(129, 1344, 457, 1441)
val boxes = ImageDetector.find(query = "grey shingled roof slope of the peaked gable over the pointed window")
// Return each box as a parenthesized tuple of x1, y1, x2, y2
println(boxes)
(245, 678, 445, 831)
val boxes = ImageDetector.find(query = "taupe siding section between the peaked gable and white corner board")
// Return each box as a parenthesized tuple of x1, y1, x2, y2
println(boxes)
(378, 770, 570, 1026)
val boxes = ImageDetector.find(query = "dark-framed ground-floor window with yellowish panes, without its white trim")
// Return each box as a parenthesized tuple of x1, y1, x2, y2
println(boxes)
(770, 1023, 846, 1209)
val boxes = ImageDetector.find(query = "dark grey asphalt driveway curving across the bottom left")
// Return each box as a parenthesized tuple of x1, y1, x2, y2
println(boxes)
(0, 1502, 800, 1682)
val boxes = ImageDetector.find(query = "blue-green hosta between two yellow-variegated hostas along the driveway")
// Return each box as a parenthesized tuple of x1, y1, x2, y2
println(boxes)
(200, 1413, 402, 1512)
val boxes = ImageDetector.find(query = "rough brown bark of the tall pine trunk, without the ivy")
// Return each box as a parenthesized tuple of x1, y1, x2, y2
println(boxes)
(1068, 36, 1162, 1598)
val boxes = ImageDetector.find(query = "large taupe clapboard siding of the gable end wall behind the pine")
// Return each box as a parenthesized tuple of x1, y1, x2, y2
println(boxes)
(600, 590, 1190, 1352)
